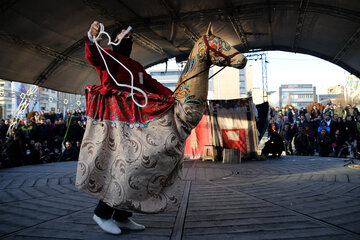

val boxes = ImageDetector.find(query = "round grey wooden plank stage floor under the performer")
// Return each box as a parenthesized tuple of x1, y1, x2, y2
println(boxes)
(0, 156, 360, 240)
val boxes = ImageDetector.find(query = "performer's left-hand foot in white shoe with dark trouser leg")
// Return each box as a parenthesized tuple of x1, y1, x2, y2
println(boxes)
(93, 200, 121, 234)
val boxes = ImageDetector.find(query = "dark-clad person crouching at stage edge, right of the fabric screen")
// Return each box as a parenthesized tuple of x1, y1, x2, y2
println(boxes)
(261, 126, 284, 159)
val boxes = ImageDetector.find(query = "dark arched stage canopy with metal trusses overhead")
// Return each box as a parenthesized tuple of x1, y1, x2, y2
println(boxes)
(0, 0, 360, 94)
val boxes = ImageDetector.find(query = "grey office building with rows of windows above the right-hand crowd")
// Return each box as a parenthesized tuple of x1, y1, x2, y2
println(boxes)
(279, 84, 317, 108)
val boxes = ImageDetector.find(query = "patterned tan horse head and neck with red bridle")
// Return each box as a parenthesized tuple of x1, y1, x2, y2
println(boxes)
(173, 23, 247, 110)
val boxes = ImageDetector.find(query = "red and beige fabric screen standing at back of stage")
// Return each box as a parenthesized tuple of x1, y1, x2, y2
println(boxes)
(185, 98, 258, 159)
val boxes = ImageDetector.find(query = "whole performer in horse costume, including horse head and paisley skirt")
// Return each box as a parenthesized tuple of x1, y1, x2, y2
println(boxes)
(76, 21, 246, 234)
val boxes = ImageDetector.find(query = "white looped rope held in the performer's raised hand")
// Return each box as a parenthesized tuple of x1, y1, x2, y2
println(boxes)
(88, 23, 148, 108)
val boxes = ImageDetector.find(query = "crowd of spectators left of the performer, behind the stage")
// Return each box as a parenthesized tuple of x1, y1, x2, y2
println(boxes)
(0, 109, 86, 168)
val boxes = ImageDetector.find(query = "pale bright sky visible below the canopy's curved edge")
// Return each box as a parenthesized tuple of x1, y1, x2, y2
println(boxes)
(147, 51, 349, 94)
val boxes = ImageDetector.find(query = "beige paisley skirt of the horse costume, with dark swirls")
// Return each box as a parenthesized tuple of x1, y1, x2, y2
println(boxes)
(76, 86, 203, 213)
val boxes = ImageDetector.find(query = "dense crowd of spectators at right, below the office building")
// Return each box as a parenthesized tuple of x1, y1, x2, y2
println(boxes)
(269, 103, 360, 158)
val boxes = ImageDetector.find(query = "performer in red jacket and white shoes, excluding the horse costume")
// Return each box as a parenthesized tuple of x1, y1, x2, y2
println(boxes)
(85, 21, 172, 235)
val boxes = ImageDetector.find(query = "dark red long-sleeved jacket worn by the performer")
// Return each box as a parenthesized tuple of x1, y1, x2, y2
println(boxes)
(85, 40, 172, 97)
